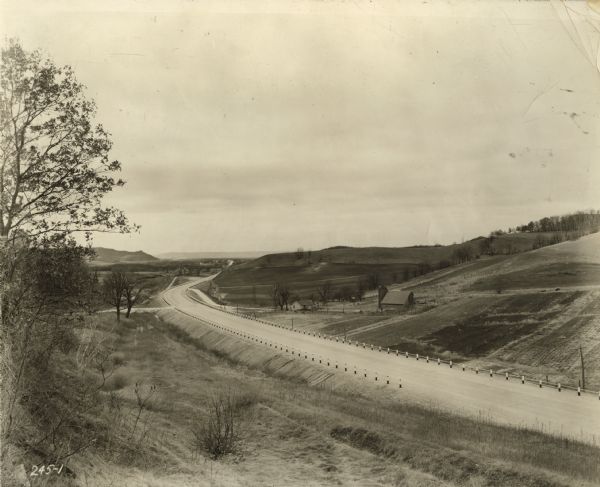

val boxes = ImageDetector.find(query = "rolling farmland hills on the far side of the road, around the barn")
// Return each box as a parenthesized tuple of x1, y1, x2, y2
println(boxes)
(211, 219, 600, 390)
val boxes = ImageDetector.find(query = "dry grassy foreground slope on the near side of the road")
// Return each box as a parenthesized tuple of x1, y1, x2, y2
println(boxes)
(38, 313, 600, 487)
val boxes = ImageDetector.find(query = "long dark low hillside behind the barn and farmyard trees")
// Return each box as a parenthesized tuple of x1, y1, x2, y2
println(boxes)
(215, 233, 568, 305)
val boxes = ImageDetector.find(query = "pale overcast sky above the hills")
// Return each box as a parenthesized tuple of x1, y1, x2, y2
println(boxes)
(2, 0, 600, 253)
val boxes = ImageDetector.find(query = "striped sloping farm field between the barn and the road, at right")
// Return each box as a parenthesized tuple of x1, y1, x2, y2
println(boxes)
(241, 234, 600, 389)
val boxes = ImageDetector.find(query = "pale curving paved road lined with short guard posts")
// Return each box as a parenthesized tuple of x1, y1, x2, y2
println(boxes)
(163, 276, 600, 444)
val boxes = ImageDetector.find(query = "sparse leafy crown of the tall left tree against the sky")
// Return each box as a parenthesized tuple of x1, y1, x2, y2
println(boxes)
(0, 40, 131, 242)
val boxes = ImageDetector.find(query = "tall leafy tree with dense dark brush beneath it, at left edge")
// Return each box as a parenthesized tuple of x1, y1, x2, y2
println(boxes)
(0, 40, 134, 483)
